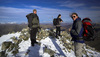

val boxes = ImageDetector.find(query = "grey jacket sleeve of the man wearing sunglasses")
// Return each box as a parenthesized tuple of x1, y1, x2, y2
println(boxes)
(71, 21, 82, 36)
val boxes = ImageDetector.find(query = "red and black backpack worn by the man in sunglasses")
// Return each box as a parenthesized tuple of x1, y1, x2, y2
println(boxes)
(82, 18, 94, 41)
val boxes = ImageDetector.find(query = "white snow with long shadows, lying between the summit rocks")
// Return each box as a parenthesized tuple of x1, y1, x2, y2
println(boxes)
(0, 32, 100, 57)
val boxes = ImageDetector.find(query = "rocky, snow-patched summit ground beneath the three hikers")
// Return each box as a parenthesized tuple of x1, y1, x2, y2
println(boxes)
(0, 29, 100, 57)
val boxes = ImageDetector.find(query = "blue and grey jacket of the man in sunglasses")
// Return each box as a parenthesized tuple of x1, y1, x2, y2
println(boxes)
(70, 18, 84, 43)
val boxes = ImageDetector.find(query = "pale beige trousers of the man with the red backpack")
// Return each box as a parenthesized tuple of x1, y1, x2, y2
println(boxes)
(74, 42, 84, 57)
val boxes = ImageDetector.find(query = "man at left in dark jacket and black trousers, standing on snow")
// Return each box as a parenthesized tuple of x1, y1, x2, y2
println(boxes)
(26, 9, 40, 46)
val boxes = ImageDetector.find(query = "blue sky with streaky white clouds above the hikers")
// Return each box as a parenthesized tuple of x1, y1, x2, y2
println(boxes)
(0, 0, 100, 23)
